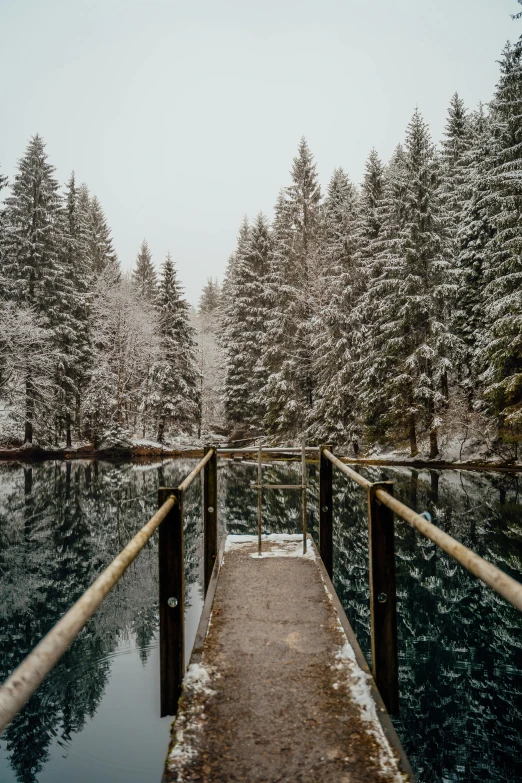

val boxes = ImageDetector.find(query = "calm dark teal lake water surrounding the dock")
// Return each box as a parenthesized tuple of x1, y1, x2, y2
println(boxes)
(0, 460, 522, 783)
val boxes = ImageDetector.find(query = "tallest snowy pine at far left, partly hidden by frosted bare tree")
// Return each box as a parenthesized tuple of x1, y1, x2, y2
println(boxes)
(3, 135, 63, 443)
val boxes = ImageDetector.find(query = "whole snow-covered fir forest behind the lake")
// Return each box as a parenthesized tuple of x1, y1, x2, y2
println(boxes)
(0, 44, 522, 460)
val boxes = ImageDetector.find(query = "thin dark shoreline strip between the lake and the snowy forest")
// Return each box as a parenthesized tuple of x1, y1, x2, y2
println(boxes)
(0, 445, 522, 473)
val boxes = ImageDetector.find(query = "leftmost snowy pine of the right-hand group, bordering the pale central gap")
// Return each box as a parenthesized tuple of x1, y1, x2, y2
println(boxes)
(220, 214, 270, 438)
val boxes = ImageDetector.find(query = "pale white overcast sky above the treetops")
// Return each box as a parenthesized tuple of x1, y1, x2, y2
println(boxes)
(0, 0, 522, 303)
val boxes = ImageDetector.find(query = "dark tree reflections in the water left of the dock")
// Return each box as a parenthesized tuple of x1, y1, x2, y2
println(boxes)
(0, 460, 201, 783)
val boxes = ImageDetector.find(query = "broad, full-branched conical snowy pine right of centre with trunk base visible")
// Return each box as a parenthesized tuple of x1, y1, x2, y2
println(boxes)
(362, 115, 458, 457)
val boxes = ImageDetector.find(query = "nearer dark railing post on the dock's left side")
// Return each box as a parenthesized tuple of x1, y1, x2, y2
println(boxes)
(158, 487, 185, 718)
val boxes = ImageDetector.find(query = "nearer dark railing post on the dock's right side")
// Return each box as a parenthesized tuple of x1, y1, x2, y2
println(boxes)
(368, 481, 399, 715)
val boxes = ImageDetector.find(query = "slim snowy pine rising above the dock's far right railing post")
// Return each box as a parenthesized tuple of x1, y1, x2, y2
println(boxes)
(311, 168, 362, 452)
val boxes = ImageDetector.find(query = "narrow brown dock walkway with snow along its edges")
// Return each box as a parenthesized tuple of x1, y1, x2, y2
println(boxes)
(163, 535, 415, 783)
